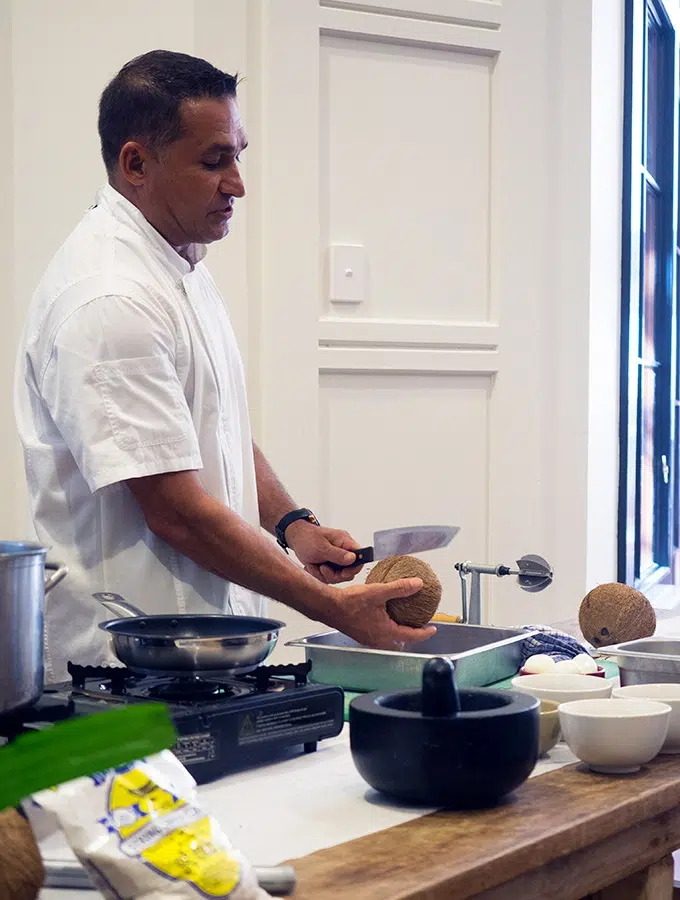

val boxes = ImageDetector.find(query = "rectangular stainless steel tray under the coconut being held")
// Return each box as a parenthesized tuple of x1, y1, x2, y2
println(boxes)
(286, 623, 537, 691)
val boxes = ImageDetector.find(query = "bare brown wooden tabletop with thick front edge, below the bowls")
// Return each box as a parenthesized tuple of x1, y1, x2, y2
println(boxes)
(292, 756, 680, 900)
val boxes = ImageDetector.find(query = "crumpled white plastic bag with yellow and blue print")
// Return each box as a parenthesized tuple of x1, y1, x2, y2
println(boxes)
(33, 751, 269, 900)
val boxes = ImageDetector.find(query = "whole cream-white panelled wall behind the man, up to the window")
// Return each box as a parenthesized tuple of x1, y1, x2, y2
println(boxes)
(0, 0, 623, 652)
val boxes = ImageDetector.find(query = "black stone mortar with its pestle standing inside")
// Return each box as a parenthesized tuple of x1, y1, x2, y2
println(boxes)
(349, 657, 540, 809)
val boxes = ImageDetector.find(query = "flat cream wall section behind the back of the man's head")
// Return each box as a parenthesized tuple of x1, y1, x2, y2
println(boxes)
(12, 0, 194, 326)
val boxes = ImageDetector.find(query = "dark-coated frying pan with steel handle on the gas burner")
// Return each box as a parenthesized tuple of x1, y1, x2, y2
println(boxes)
(92, 592, 284, 677)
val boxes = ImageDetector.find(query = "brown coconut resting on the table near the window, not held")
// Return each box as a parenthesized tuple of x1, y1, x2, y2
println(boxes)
(578, 583, 656, 647)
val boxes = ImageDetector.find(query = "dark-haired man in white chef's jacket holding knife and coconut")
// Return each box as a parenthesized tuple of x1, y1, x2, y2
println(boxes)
(15, 51, 434, 682)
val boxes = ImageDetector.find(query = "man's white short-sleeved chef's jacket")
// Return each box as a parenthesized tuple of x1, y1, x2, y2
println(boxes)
(15, 185, 264, 682)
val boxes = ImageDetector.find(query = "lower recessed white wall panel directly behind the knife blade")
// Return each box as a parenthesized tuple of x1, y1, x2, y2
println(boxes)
(319, 374, 492, 613)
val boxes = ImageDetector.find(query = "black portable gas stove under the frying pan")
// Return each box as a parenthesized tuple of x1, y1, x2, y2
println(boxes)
(0, 663, 344, 784)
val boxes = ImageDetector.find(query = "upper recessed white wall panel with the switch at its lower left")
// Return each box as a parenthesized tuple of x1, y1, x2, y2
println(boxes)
(320, 37, 493, 321)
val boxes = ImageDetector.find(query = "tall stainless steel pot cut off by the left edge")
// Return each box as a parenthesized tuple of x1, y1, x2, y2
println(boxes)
(0, 541, 68, 715)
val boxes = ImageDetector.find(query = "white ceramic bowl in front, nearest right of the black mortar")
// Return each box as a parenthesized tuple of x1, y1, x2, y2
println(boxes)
(558, 696, 671, 775)
